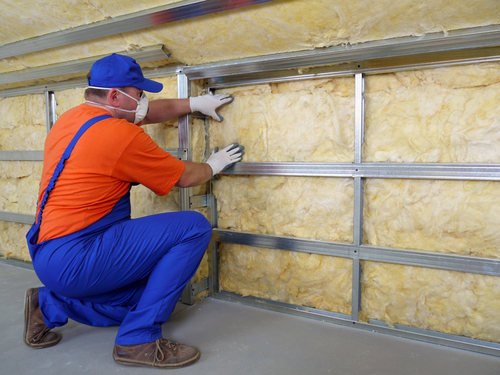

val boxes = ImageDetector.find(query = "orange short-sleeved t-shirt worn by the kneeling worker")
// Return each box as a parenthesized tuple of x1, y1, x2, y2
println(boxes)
(37, 104, 184, 242)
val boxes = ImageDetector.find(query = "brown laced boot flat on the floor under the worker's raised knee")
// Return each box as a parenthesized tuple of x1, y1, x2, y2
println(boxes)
(113, 338, 200, 369)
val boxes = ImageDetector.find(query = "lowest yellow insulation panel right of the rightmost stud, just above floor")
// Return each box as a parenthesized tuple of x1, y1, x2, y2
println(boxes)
(361, 262, 500, 342)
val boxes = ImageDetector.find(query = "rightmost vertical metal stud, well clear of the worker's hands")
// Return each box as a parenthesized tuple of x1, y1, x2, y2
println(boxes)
(351, 73, 365, 321)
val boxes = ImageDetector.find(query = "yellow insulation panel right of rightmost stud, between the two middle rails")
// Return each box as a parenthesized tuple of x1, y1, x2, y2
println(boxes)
(363, 179, 500, 258)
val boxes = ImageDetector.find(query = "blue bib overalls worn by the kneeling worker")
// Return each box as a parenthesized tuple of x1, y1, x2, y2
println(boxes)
(26, 115, 212, 345)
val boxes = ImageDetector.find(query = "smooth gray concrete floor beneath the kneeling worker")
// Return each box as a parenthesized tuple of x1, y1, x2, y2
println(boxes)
(0, 262, 500, 375)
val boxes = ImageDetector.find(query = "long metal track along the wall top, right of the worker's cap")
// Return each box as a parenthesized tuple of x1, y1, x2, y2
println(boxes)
(183, 25, 500, 88)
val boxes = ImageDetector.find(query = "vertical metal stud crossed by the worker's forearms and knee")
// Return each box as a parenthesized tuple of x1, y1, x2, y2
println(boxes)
(177, 73, 194, 305)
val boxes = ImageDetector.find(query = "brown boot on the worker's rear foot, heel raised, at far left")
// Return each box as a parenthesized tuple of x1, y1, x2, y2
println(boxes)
(23, 288, 61, 349)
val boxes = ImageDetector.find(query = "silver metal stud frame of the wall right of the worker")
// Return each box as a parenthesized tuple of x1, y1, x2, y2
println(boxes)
(197, 33, 500, 356)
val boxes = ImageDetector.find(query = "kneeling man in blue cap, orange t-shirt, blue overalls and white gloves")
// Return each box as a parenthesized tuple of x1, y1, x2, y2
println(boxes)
(23, 54, 243, 368)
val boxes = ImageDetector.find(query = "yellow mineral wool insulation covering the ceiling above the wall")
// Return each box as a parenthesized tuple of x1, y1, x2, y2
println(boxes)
(0, 0, 500, 72)
